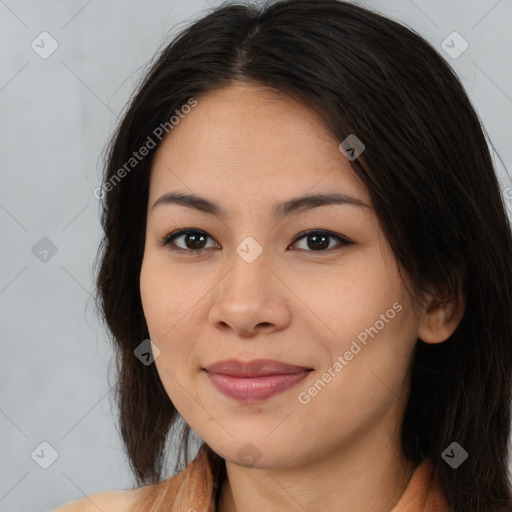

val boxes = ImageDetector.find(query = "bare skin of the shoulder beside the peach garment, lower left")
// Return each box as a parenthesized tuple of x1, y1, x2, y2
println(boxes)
(51, 488, 145, 512)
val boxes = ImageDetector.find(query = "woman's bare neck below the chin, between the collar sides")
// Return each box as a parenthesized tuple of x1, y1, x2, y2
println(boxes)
(217, 432, 416, 512)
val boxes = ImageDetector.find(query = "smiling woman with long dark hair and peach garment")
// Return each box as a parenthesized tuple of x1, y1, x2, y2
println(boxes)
(55, 0, 512, 512)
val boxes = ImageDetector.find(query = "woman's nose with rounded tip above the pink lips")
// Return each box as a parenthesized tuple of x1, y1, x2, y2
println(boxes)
(209, 246, 292, 337)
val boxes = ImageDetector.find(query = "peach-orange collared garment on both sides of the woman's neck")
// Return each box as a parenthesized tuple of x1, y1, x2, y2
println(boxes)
(132, 450, 450, 512)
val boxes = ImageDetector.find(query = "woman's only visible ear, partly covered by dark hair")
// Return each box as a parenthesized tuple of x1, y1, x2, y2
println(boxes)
(418, 284, 466, 343)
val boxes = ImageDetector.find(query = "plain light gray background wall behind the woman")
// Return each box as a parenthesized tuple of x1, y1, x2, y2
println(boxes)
(0, 0, 512, 512)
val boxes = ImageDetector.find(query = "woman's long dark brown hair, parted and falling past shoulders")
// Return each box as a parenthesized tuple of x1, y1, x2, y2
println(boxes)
(97, 0, 512, 512)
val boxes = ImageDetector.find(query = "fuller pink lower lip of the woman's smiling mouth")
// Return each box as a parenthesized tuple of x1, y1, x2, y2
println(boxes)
(205, 370, 311, 402)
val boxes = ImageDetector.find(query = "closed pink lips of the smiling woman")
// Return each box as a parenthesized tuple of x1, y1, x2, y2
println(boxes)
(204, 359, 312, 402)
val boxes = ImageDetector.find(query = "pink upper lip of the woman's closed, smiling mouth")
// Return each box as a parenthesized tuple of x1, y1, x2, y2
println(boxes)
(204, 359, 312, 377)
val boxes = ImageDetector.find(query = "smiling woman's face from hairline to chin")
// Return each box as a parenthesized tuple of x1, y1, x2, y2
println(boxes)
(140, 84, 419, 468)
